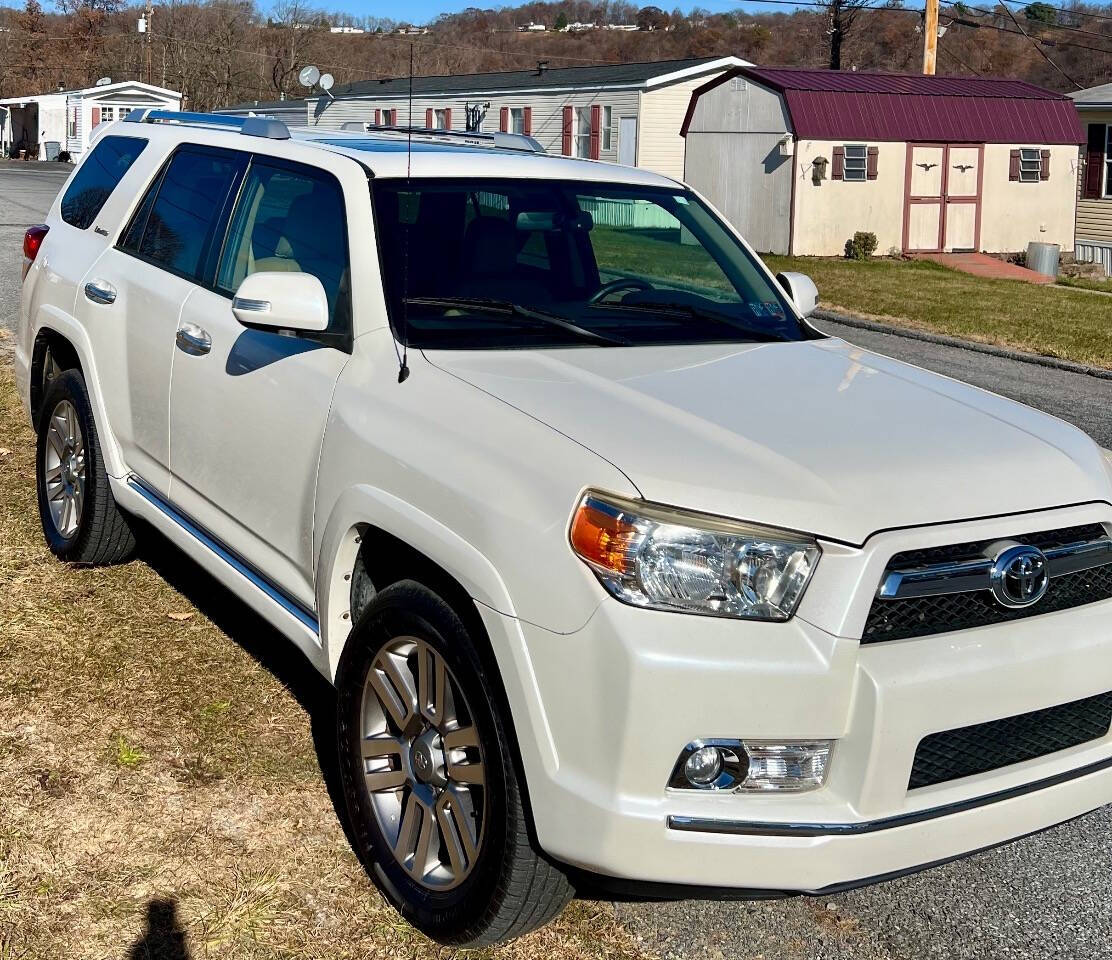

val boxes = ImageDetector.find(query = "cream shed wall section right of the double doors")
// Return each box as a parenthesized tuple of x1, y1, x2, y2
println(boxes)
(981, 143, 1079, 253)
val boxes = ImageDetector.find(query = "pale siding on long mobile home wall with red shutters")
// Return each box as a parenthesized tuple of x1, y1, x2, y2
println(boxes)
(309, 90, 644, 164)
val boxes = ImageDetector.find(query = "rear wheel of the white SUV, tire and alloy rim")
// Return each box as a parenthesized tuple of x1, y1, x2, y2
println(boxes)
(34, 369, 136, 566)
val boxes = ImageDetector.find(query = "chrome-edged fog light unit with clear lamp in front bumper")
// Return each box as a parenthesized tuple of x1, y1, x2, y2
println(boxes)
(668, 740, 834, 792)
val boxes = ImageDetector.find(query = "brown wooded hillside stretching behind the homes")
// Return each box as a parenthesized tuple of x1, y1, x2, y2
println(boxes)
(0, 0, 1112, 110)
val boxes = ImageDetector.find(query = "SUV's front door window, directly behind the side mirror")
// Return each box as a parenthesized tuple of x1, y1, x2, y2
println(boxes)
(217, 159, 351, 327)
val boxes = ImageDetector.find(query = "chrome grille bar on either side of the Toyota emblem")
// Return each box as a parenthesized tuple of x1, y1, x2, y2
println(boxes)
(876, 536, 1112, 600)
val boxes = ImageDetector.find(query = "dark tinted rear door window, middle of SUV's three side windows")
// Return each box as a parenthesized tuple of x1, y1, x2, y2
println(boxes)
(133, 150, 242, 280)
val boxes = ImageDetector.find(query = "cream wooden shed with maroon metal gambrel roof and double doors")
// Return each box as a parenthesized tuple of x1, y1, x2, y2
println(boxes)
(683, 67, 1084, 256)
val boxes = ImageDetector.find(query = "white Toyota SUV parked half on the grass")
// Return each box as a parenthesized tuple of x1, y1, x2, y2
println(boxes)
(17, 115, 1112, 944)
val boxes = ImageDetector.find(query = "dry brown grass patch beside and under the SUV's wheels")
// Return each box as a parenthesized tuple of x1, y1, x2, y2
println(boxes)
(0, 363, 642, 960)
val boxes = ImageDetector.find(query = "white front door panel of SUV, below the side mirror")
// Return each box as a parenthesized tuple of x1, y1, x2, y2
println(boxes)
(169, 288, 348, 611)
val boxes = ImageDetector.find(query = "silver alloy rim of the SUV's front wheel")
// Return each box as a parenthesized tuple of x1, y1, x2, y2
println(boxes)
(360, 636, 487, 891)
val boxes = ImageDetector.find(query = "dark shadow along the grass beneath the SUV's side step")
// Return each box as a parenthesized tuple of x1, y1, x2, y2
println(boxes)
(133, 522, 354, 847)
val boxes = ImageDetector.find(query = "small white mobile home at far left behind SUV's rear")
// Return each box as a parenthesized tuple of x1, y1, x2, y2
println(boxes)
(0, 80, 181, 160)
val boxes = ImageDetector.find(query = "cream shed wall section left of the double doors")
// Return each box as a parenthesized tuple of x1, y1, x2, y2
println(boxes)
(792, 140, 907, 257)
